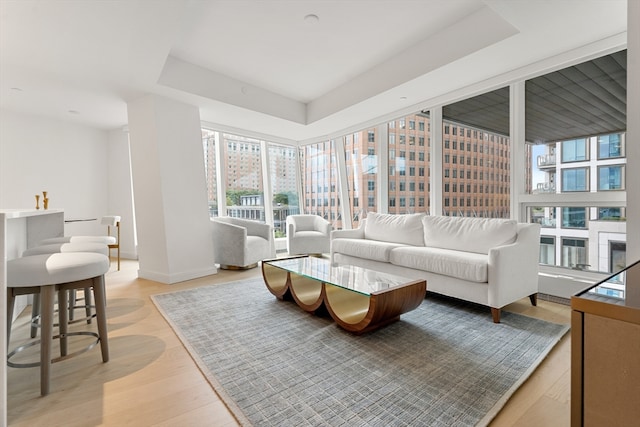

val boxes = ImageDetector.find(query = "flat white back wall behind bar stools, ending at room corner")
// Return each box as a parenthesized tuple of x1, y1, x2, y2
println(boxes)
(0, 110, 108, 234)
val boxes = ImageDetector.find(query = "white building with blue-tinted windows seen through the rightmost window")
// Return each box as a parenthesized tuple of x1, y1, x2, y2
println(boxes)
(532, 133, 626, 273)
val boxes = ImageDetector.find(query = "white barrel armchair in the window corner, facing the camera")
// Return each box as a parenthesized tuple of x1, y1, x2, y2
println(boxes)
(287, 215, 331, 255)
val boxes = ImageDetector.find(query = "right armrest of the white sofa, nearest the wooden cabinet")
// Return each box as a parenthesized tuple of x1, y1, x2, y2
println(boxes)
(488, 223, 540, 308)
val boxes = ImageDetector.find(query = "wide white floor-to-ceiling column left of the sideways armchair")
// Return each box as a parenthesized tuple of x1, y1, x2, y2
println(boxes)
(127, 95, 217, 283)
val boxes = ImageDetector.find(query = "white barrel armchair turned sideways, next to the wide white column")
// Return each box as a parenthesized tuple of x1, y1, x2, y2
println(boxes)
(211, 217, 276, 270)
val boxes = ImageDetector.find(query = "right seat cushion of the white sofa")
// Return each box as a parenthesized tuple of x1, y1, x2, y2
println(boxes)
(389, 246, 489, 286)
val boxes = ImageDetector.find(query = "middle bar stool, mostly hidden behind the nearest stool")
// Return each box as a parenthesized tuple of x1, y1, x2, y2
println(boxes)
(22, 242, 109, 338)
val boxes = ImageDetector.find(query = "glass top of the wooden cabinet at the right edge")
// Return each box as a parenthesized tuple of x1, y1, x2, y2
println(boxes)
(576, 261, 640, 308)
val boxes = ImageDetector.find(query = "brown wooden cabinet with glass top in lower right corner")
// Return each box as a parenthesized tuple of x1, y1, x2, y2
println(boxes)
(571, 262, 640, 427)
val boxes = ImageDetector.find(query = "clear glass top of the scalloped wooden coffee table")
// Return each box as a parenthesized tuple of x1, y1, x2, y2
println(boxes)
(264, 257, 414, 295)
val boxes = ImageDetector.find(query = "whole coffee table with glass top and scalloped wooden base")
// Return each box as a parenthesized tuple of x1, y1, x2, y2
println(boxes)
(262, 256, 427, 333)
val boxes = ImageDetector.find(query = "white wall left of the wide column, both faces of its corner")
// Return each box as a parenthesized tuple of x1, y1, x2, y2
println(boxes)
(0, 110, 136, 258)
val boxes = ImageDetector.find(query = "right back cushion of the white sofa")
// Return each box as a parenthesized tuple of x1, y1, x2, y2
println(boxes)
(422, 216, 518, 254)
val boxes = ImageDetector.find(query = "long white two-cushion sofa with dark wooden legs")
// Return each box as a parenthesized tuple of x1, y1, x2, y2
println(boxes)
(331, 213, 540, 323)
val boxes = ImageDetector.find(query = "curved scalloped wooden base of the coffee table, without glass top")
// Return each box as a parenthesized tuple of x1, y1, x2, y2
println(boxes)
(262, 263, 427, 334)
